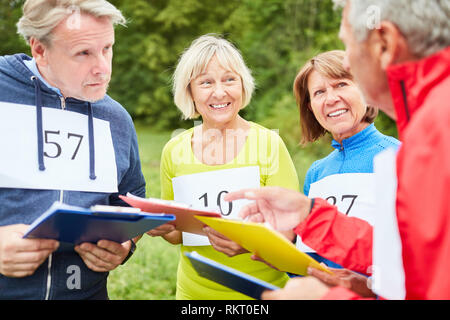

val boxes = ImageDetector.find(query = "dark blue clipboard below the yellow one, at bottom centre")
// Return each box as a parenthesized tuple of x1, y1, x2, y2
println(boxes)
(184, 251, 280, 300)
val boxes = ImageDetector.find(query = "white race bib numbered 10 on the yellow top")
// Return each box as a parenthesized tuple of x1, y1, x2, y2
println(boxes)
(172, 166, 260, 246)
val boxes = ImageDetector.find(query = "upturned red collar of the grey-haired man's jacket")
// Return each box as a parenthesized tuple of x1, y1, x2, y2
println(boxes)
(386, 47, 450, 137)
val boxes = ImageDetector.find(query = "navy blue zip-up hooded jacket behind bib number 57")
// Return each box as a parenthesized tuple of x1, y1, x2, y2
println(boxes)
(0, 54, 145, 299)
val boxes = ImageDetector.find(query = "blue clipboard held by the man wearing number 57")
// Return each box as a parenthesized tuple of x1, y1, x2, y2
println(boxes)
(23, 202, 175, 244)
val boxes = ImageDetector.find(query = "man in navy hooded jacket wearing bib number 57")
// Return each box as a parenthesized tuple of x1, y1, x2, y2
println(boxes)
(0, 0, 145, 299)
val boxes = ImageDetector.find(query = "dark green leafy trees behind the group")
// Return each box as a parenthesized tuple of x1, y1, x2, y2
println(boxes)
(0, 0, 396, 148)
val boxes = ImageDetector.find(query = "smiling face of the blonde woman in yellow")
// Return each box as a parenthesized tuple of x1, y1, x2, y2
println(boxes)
(190, 56, 246, 128)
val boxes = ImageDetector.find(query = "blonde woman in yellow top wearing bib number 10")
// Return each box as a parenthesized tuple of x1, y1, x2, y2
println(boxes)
(149, 35, 299, 300)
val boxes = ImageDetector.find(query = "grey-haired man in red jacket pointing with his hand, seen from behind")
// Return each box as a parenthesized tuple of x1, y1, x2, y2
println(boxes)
(225, 0, 450, 299)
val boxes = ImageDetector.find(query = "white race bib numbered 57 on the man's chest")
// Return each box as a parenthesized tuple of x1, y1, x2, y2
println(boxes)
(0, 102, 117, 193)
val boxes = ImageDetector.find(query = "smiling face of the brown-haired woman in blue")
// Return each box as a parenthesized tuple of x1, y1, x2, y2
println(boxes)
(308, 70, 369, 142)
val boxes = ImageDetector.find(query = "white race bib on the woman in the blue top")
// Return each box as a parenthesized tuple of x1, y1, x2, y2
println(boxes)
(297, 173, 375, 252)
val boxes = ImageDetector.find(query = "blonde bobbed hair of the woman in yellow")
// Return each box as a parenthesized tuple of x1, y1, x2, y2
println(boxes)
(172, 34, 255, 119)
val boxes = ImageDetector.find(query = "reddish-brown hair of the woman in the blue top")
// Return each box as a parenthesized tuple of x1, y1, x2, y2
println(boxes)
(293, 50, 378, 145)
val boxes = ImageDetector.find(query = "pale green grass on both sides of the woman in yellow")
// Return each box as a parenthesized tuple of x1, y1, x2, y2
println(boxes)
(108, 125, 329, 300)
